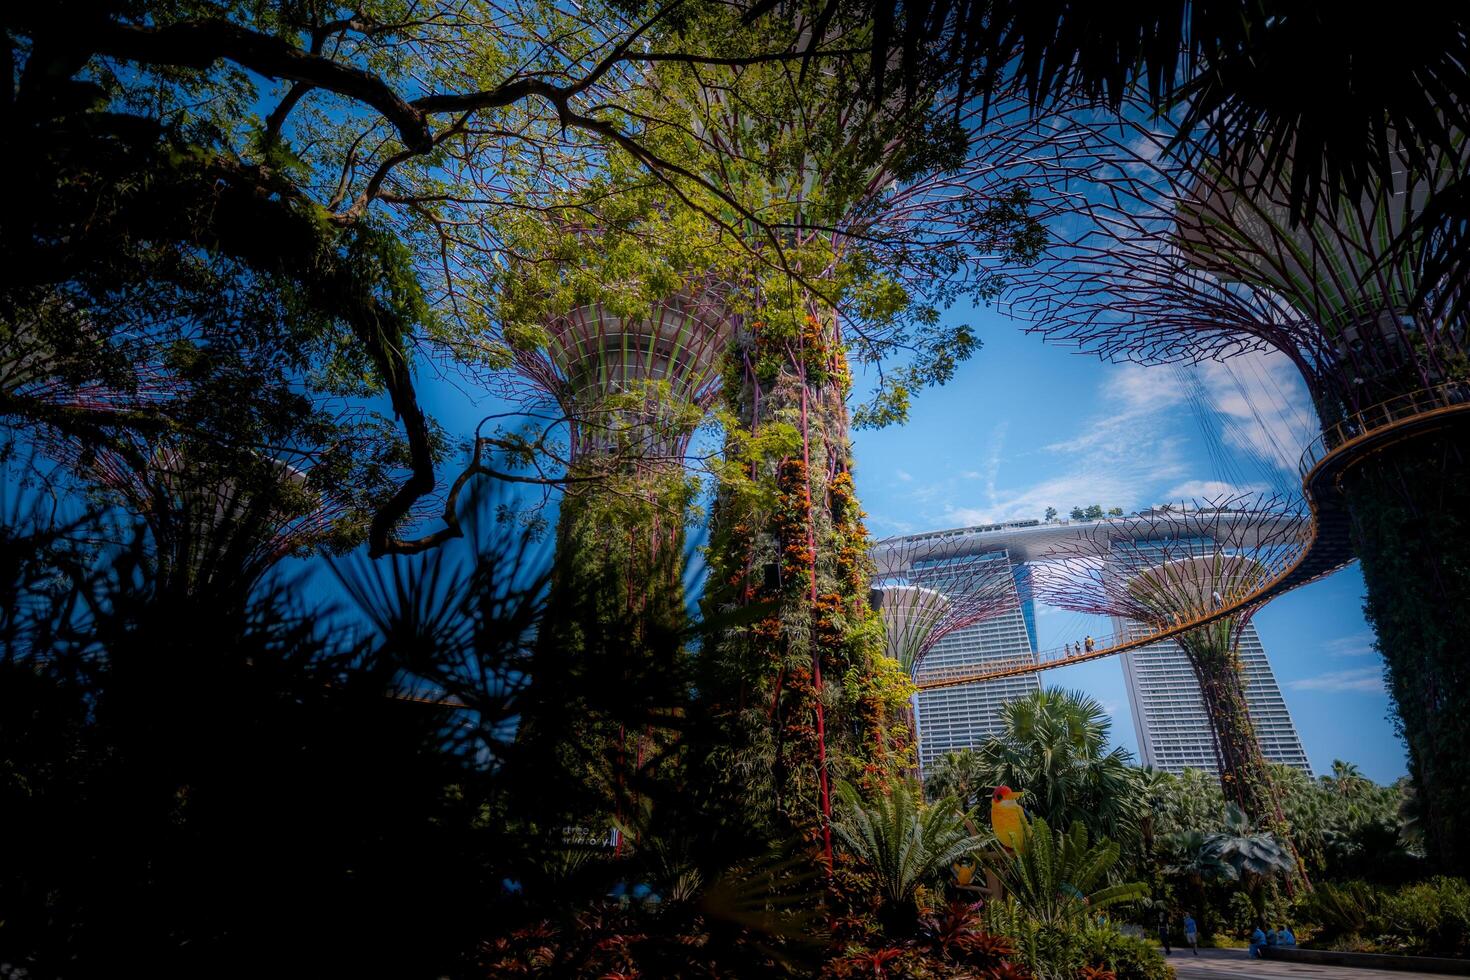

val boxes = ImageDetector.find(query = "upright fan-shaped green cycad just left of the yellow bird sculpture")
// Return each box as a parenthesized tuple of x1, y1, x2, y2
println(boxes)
(832, 780, 985, 933)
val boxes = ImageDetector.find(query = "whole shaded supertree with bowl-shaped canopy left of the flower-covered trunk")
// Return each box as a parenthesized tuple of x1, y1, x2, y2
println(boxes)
(488, 258, 731, 820)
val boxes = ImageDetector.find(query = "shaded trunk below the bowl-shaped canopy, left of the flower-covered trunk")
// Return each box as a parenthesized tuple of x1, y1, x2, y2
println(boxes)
(519, 464, 692, 826)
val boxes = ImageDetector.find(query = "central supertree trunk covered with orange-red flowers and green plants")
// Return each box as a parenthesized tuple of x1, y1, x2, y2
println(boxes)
(711, 310, 901, 861)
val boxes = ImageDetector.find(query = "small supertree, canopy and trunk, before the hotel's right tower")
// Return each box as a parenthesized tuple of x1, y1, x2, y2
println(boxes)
(1036, 497, 1310, 875)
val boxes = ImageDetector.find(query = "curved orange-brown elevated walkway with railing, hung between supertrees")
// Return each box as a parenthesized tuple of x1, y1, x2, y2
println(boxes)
(914, 382, 1470, 691)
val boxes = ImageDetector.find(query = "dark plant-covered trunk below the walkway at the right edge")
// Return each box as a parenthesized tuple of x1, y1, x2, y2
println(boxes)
(1345, 435, 1470, 874)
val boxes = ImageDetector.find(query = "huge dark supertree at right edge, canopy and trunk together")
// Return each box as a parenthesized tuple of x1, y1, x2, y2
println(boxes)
(1008, 116, 1470, 868)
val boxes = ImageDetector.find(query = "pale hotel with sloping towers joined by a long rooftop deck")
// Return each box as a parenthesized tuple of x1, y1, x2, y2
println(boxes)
(879, 519, 1311, 773)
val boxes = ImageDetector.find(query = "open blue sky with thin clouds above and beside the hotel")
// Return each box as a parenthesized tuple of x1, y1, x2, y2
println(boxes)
(854, 310, 1405, 782)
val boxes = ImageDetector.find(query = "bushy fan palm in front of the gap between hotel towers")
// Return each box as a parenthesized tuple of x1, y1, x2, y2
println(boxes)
(976, 689, 1148, 848)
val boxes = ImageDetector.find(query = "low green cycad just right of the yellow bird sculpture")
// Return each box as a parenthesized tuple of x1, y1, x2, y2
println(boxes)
(992, 817, 1148, 926)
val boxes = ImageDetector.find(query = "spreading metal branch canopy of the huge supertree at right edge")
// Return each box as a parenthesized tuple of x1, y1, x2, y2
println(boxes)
(1004, 113, 1470, 423)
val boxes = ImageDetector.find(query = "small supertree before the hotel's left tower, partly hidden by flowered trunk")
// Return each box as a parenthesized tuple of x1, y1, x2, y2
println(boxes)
(869, 536, 1023, 771)
